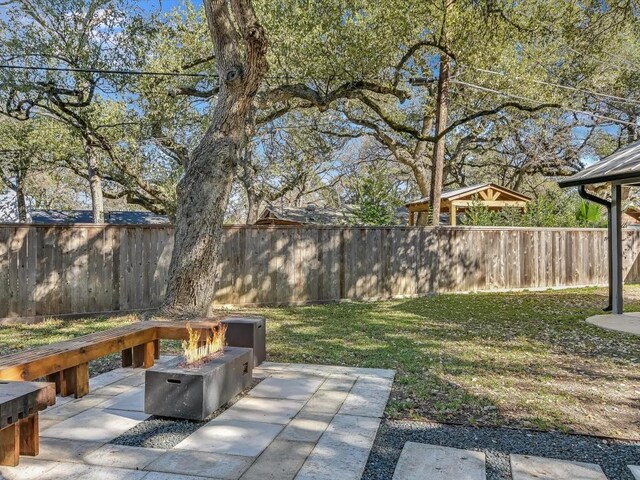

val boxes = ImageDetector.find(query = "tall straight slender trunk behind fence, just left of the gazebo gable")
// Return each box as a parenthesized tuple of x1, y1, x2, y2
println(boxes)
(429, 53, 450, 225)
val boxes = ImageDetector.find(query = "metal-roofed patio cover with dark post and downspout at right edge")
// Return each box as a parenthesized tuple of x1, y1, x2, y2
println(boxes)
(558, 141, 640, 331)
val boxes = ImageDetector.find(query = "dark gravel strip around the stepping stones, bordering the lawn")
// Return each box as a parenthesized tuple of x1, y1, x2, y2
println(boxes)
(362, 420, 640, 480)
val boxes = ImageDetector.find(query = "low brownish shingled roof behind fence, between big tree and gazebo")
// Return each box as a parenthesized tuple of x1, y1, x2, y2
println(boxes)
(256, 204, 356, 225)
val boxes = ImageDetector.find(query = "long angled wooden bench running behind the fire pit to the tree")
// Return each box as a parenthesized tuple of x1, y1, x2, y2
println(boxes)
(0, 320, 219, 398)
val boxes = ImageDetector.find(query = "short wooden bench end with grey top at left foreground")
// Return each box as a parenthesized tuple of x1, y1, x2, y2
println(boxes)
(0, 381, 56, 467)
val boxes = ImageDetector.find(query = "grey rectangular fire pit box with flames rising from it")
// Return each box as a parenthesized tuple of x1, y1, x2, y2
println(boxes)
(144, 347, 253, 420)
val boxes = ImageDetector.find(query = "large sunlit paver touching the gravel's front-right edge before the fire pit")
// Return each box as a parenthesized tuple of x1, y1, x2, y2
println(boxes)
(175, 417, 282, 457)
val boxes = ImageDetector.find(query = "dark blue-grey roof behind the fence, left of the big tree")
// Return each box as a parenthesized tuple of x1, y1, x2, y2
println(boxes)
(30, 210, 171, 225)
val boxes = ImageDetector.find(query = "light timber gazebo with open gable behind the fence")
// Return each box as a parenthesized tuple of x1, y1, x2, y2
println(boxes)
(406, 183, 531, 226)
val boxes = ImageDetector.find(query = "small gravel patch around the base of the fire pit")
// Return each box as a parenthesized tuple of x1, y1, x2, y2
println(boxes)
(109, 378, 262, 449)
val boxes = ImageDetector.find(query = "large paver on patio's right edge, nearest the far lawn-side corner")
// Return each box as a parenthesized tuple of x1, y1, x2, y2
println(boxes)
(339, 377, 393, 417)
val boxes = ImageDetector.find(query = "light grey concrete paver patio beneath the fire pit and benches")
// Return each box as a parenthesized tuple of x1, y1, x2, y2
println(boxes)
(0, 357, 394, 480)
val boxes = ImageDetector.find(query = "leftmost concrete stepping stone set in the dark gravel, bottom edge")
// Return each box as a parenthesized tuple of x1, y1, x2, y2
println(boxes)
(393, 442, 484, 480)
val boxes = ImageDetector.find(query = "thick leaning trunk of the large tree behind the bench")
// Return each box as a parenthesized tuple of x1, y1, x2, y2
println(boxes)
(160, 0, 268, 317)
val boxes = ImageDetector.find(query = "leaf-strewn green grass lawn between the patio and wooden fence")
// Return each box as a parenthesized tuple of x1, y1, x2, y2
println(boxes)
(0, 286, 640, 439)
